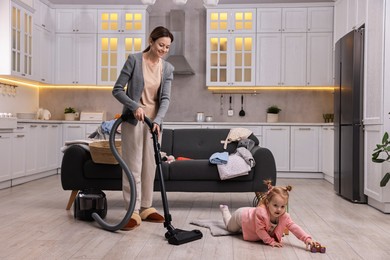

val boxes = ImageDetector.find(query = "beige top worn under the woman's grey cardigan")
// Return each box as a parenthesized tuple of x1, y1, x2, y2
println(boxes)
(141, 58, 162, 119)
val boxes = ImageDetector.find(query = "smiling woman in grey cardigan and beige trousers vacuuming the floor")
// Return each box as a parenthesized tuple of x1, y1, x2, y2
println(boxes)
(112, 26, 174, 230)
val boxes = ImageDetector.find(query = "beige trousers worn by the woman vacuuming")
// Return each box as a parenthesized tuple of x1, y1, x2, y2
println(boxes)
(121, 122, 156, 213)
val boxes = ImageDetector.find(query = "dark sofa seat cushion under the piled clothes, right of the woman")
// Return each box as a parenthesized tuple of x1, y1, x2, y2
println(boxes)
(169, 159, 254, 181)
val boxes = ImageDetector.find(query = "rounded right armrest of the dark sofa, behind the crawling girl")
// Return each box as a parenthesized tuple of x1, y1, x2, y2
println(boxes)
(251, 146, 276, 192)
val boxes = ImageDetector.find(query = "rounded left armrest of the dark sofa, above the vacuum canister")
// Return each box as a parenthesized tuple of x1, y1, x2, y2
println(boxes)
(61, 145, 91, 190)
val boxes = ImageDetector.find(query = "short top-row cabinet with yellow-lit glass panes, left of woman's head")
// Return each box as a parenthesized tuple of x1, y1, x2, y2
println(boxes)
(98, 10, 149, 34)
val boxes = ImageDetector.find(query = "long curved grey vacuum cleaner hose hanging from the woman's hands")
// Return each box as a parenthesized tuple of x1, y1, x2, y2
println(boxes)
(92, 116, 137, 231)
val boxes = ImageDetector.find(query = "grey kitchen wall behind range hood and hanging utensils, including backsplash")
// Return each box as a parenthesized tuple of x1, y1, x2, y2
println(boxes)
(39, 1, 333, 123)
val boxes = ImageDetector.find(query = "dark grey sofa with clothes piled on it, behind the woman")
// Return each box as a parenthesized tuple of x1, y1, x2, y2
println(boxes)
(61, 129, 276, 209)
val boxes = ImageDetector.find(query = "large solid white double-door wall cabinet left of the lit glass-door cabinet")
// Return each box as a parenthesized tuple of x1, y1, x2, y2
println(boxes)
(55, 33, 96, 85)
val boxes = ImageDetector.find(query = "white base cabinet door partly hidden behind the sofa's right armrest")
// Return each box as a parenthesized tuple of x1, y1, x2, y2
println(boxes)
(263, 125, 290, 172)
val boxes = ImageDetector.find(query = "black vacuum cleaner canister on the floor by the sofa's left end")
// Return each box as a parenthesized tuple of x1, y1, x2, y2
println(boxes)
(73, 190, 107, 221)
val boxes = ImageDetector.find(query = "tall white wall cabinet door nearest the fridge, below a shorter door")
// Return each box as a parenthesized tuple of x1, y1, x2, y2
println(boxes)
(306, 32, 333, 86)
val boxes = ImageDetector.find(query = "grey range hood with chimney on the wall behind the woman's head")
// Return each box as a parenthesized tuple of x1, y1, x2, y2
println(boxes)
(166, 10, 195, 75)
